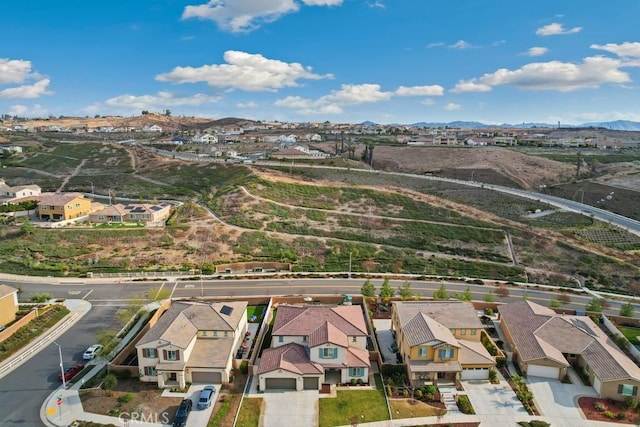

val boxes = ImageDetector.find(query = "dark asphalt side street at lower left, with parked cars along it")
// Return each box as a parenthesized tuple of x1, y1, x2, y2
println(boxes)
(0, 307, 118, 427)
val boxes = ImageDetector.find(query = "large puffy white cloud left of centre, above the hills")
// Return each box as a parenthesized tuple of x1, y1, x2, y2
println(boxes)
(156, 50, 333, 92)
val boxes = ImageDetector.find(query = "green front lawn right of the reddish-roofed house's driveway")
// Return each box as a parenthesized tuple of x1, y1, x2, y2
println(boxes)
(319, 381, 389, 427)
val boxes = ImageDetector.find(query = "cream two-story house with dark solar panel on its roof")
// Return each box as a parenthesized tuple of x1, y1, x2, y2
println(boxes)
(136, 301, 247, 388)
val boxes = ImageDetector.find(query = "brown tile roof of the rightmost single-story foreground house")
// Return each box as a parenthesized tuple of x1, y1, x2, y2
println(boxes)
(500, 301, 640, 382)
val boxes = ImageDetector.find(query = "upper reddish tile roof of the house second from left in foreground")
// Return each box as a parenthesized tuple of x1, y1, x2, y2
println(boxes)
(273, 305, 367, 337)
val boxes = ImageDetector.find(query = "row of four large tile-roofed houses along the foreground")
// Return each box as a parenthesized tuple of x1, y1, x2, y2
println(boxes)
(136, 301, 640, 400)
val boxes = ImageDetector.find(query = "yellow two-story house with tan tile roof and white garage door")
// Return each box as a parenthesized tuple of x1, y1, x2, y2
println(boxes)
(391, 301, 496, 387)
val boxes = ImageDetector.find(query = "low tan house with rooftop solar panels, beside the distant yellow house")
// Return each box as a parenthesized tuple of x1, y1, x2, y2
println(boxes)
(89, 203, 171, 224)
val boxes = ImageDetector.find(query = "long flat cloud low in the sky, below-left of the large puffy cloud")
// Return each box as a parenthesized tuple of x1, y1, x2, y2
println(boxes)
(85, 92, 222, 113)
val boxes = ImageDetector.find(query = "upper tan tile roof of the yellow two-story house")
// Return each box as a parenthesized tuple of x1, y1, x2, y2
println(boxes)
(393, 301, 482, 329)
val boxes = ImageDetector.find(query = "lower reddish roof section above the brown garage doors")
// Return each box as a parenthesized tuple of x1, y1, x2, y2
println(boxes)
(256, 343, 324, 375)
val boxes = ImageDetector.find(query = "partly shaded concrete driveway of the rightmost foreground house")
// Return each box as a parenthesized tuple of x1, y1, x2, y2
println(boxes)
(527, 377, 597, 423)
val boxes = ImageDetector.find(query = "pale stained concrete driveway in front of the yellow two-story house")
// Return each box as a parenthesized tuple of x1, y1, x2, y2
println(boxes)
(461, 378, 528, 416)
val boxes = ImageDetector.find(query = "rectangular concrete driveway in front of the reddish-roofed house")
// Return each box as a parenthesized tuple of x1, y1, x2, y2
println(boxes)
(260, 390, 319, 427)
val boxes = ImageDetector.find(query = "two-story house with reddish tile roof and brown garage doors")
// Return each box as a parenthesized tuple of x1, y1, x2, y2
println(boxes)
(256, 305, 371, 391)
